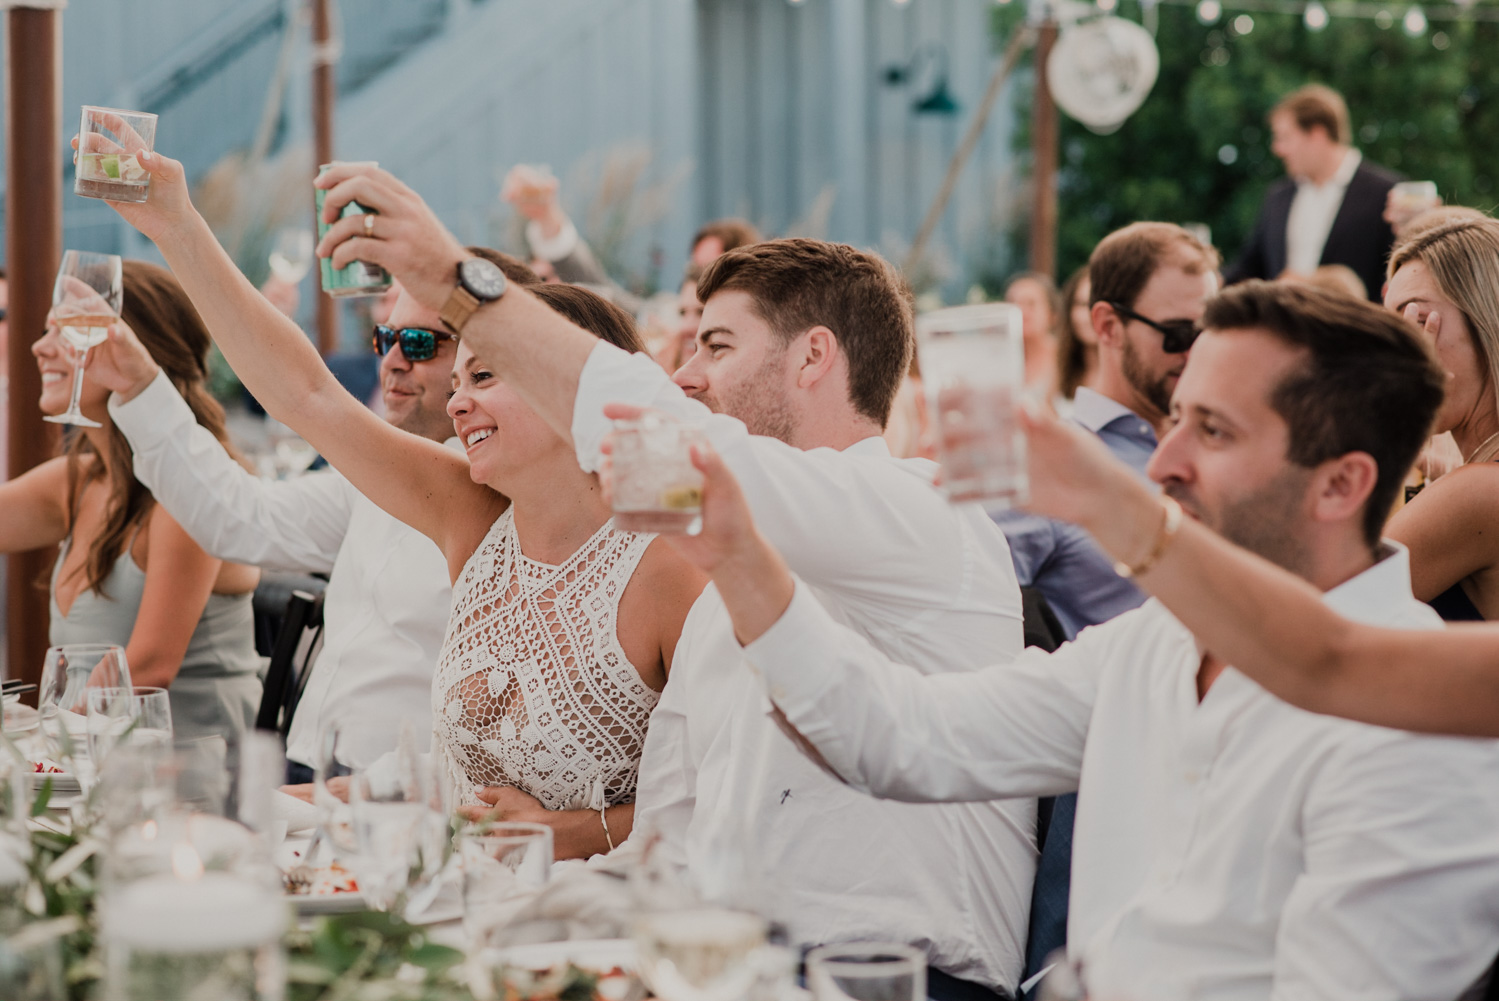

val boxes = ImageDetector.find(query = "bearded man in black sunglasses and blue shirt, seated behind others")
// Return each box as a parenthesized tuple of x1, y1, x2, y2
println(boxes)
(995, 222, 1219, 976)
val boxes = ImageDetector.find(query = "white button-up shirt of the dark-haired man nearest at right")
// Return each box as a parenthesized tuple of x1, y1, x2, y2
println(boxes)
(745, 548, 1499, 1001)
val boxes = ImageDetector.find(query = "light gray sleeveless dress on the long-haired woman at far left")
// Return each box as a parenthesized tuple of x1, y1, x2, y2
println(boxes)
(48, 538, 261, 743)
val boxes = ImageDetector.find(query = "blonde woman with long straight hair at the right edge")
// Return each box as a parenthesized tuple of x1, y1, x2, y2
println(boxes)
(1385, 217, 1499, 620)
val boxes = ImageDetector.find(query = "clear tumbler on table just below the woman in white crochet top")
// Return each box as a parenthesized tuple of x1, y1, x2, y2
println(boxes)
(459, 821, 553, 949)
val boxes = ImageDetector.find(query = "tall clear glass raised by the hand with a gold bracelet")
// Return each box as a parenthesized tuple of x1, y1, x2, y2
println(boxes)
(916, 303, 1028, 506)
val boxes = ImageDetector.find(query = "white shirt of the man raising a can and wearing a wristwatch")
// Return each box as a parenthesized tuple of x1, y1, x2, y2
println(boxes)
(573, 345, 1036, 991)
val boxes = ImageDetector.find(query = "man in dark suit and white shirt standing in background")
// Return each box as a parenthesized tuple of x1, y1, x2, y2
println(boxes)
(1223, 84, 1400, 301)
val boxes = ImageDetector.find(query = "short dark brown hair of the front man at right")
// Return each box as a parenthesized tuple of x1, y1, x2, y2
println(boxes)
(1202, 280, 1447, 548)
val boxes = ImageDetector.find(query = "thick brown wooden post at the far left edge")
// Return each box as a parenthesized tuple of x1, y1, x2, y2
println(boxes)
(0, 0, 63, 695)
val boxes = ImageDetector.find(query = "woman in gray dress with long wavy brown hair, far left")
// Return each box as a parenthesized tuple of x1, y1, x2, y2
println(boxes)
(0, 261, 261, 742)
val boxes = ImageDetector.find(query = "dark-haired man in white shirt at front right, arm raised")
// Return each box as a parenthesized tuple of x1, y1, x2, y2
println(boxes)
(677, 283, 1499, 1001)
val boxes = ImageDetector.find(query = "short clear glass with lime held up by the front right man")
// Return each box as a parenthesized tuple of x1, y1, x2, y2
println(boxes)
(613, 417, 706, 535)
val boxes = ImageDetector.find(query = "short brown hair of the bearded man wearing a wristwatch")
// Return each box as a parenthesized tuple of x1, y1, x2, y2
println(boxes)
(697, 238, 916, 427)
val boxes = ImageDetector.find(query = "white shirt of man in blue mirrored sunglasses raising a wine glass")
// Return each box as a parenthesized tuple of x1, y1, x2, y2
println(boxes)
(109, 373, 456, 767)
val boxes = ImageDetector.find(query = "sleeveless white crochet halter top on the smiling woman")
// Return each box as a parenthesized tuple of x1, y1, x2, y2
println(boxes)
(432, 509, 660, 809)
